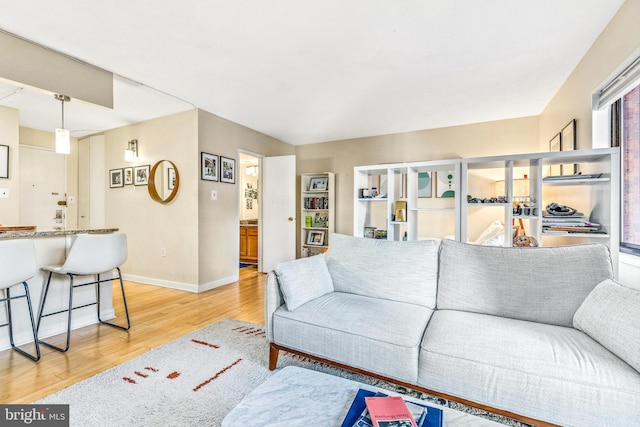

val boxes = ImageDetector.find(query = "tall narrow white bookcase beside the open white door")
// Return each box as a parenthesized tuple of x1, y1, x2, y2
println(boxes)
(300, 172, 335, 257)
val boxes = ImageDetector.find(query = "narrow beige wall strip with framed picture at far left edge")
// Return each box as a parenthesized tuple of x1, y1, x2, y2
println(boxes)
(0, 106, 20, 225)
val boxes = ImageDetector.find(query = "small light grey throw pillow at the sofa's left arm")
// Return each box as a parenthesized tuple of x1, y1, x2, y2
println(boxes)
(275, 255, 333, 311)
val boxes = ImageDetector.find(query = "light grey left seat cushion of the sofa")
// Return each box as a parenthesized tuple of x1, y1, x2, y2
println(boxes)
(273, 292, 433, 383)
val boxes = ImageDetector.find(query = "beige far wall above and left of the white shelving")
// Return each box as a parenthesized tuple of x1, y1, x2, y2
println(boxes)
(296, 117, 540, 239)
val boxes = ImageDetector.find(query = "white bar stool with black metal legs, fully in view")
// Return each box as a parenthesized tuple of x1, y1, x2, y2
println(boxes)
(36, 233, 131, 352)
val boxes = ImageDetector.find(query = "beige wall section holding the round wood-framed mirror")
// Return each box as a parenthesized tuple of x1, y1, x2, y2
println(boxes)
(105, 110, 198, 291)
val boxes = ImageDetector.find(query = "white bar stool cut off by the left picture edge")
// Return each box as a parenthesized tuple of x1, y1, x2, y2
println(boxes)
(0, 240, 40, 362)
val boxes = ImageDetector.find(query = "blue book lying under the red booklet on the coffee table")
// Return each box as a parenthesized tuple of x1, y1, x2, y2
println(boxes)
(341, 389, 443, 427)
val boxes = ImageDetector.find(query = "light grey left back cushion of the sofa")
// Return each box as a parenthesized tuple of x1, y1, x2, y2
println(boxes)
(325, 234, 439, 309)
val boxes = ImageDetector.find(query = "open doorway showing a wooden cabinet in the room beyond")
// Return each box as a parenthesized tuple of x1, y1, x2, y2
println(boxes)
(238, 152, 261, 273)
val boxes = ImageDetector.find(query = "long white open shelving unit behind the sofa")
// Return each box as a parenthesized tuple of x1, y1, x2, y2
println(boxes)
(353, 148, 620, 272)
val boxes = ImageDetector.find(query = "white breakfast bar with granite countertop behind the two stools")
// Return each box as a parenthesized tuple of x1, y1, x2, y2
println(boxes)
(0, 228, 118, 351)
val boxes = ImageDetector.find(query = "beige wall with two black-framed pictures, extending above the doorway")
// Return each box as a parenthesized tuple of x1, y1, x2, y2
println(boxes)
(192, 110, 294, 290)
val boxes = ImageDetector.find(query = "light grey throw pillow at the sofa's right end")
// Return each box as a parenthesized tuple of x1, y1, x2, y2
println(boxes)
(573, 279, 640, 372)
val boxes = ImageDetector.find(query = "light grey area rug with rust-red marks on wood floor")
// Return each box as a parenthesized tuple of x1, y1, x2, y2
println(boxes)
(34, 319, 524, 427)
